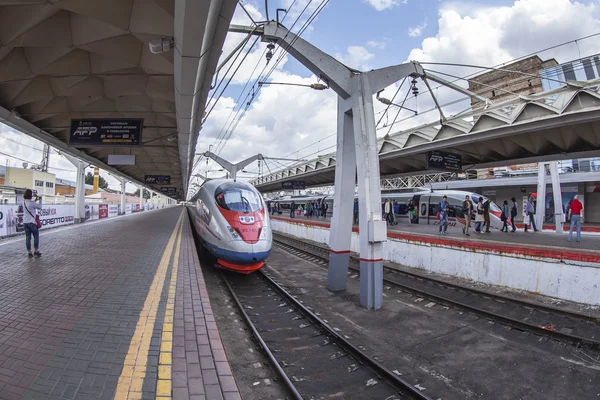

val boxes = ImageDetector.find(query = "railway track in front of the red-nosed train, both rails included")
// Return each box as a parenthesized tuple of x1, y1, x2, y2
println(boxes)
(222, 271, 429, 400)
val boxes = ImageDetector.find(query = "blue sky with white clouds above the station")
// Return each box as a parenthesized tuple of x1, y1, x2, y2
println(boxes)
(0, 0, 600, 194)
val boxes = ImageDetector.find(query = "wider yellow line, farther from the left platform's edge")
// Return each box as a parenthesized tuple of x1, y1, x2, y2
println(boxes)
(115, 211, 183, 400)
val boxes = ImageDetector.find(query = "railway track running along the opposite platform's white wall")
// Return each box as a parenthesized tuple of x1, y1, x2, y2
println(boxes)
(273, 234, 600, 350)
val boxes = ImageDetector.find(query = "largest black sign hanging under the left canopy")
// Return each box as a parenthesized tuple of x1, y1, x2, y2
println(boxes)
(69, 118, 144, 147)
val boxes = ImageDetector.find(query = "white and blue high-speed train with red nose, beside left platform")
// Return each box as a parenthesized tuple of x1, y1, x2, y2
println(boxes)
(190, 179, 273, 274)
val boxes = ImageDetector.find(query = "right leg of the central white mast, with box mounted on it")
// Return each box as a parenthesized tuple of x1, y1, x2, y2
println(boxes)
(352, 73, 387, 309)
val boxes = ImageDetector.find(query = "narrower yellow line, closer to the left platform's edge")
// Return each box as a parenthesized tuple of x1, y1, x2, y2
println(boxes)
(156, 214, 181, 400)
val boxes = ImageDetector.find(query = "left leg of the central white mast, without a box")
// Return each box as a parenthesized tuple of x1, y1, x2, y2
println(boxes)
(327, 101, 356, 291)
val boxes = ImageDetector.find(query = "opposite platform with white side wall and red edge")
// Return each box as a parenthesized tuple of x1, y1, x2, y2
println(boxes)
(271, 216, 600, 306)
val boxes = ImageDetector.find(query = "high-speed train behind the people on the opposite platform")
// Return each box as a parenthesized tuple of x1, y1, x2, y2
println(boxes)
(274, 188, 510, 229)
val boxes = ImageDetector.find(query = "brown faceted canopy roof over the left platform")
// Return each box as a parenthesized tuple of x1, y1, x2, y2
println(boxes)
(0, 0, 237, 198)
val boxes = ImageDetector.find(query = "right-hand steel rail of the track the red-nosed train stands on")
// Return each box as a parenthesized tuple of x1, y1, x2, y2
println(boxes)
(259, 264, 432, 400)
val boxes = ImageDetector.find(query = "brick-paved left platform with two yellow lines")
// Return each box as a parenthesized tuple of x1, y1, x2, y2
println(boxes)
(0, 207, 240, 400)
